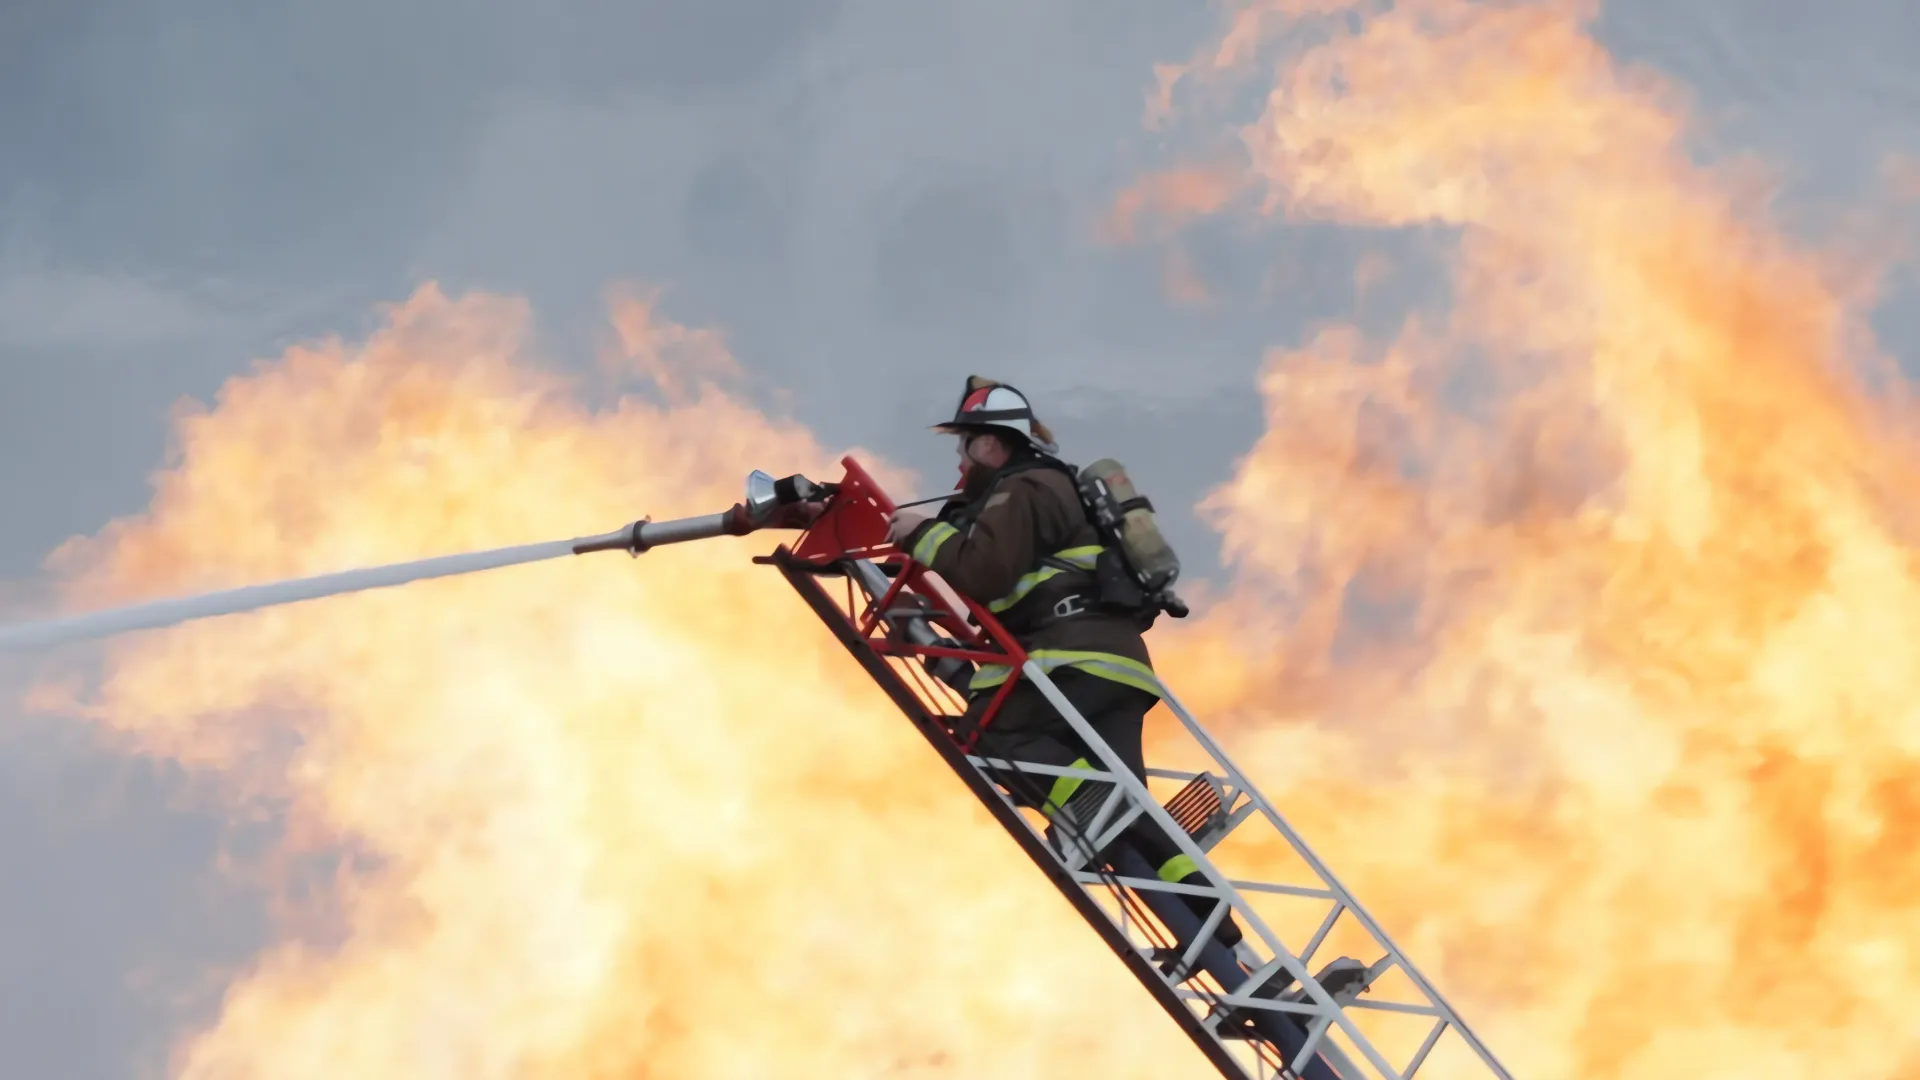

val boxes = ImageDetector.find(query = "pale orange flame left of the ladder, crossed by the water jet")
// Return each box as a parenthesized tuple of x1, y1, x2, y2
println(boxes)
(33, 288, 1198, 1080)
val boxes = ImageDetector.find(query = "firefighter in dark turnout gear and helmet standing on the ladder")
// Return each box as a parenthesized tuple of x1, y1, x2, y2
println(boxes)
(887, 375, 1242, 947)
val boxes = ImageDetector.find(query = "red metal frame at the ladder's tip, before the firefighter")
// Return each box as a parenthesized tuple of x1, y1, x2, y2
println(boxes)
(791, 455, 1027, 751)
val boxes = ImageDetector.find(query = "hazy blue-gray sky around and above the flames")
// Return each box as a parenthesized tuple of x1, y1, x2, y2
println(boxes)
(0, 0, 1920, 1078)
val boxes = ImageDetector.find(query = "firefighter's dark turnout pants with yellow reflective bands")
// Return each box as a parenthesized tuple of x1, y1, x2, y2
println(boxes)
(954, 667, 1240, 947)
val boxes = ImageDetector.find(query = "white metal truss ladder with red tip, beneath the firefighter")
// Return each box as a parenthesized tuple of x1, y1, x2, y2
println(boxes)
(756, 457, 1511, 1080)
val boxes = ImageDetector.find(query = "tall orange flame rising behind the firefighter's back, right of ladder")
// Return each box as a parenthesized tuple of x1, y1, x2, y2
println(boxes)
(1125, 0, 1920, 1078)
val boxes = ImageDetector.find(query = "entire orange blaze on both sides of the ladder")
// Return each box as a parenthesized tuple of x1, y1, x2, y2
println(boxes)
(22, 0, 1920, 1080)
